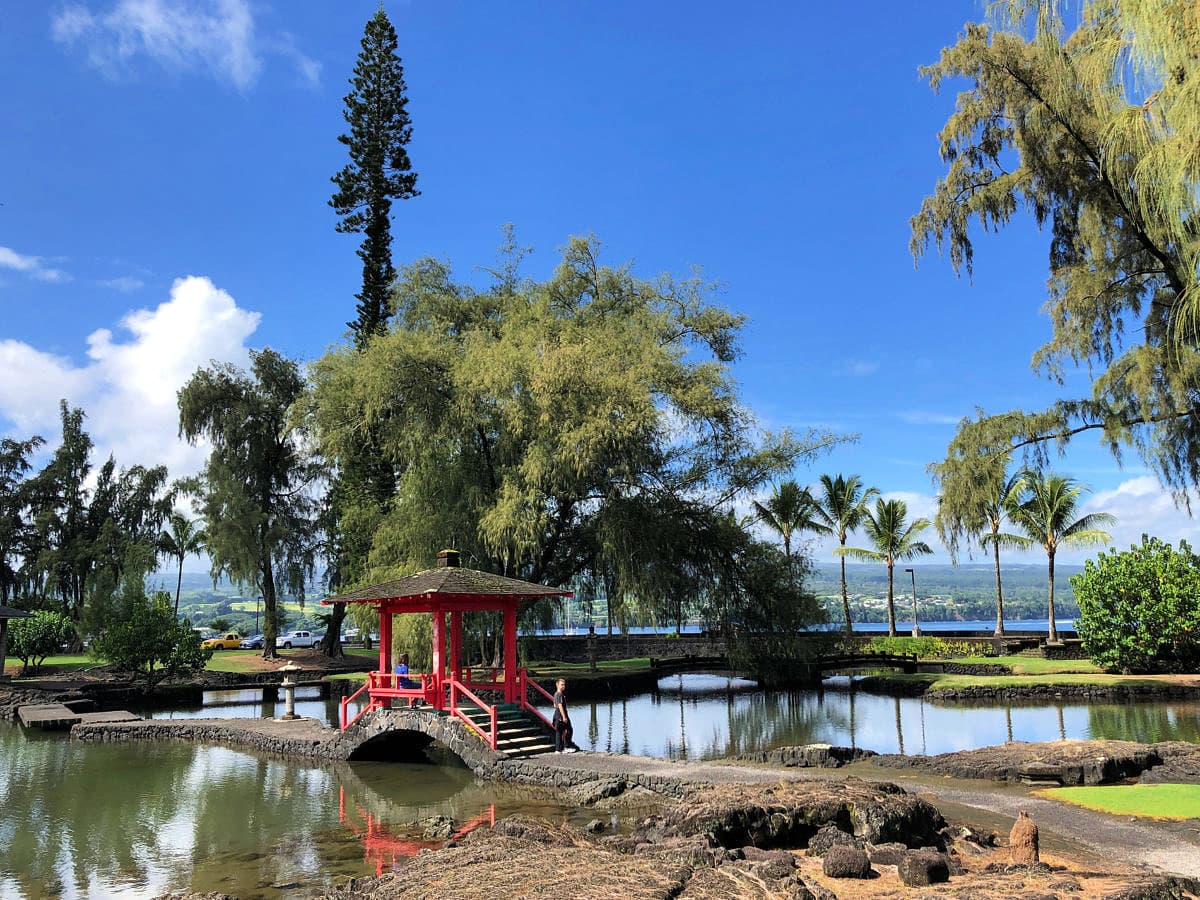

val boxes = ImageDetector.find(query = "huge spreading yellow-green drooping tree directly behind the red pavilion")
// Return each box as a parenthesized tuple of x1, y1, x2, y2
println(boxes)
(310, 238, 840, 652)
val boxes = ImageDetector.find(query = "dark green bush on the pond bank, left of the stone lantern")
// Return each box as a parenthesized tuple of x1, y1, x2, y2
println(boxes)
(91, 592, 212, 689)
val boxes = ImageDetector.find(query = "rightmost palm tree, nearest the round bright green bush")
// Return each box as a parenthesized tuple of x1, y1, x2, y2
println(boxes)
(1008, 469, 1116, 643)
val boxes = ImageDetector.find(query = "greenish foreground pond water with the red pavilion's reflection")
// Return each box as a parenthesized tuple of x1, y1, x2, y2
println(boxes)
(0, 724, 609, 900)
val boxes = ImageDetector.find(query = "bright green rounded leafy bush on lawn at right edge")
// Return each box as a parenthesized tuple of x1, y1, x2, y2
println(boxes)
(1070, 535, 1200, 672)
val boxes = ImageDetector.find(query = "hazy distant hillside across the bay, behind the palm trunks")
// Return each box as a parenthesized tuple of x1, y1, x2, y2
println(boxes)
(808, 563, 1084, 622)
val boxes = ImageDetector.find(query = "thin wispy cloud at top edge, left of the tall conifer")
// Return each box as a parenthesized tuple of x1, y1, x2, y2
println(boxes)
(50, 0, 320, 90)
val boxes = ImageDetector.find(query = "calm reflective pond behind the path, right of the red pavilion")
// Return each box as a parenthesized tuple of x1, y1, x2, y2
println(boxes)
(566, 674, 1200, 760)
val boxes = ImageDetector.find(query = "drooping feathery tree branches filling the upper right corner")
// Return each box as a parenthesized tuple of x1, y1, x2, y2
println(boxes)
(912, 0, 1200, 501)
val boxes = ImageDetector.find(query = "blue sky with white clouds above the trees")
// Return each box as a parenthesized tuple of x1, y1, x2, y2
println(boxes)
(0, 0, 1180, 562)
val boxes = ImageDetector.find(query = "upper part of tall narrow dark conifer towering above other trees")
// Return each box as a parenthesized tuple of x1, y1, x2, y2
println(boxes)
(329, 5, 418, 347)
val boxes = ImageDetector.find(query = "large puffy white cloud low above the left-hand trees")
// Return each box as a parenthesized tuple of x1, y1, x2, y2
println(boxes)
(0, 276, 260, 476)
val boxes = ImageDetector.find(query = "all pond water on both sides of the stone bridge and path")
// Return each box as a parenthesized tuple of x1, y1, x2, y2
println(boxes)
(0, 674, 1200, 899)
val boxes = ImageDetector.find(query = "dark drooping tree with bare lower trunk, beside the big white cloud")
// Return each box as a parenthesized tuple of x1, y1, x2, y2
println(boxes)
(179, 349, 322, 658)
